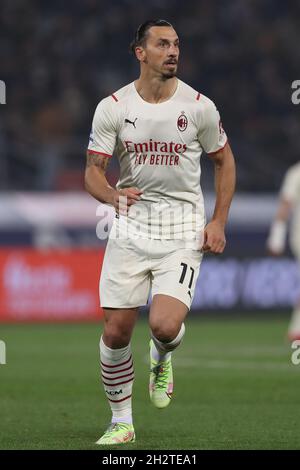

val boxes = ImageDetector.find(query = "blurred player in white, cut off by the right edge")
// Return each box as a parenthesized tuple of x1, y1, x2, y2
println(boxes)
(267, 163, 300, 341)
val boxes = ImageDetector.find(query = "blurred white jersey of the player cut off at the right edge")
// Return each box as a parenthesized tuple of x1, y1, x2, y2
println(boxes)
(280, 163, 300, 257)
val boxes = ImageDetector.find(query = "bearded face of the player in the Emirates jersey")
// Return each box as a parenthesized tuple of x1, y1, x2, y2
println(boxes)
(145, 27, 179, 79)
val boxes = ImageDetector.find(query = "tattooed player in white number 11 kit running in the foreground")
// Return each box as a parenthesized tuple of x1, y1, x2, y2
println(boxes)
(85, 20, 235, 445)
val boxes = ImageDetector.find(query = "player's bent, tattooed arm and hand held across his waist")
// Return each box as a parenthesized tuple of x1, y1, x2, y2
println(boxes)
(85, 150, 142, 212)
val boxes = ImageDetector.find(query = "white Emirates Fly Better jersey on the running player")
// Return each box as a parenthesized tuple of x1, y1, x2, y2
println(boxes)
(88, 80, 227, 240)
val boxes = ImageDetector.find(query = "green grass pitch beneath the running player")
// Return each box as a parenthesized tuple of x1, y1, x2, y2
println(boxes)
(0, 315, 300, 452)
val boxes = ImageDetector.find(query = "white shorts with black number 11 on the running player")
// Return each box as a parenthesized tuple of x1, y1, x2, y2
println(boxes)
(99, 238, 203, 309)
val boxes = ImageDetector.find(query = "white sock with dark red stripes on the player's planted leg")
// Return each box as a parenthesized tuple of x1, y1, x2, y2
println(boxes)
(99, 336, 134, 424)
